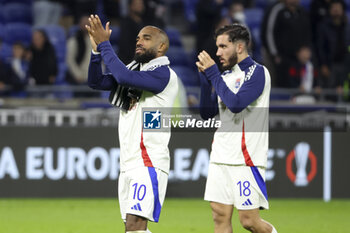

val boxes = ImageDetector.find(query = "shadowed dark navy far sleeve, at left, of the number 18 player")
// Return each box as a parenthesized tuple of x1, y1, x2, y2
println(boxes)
(199, 72, 219, 120)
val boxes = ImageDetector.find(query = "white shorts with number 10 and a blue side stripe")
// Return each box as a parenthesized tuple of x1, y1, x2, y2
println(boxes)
(118, 167, 168, 222)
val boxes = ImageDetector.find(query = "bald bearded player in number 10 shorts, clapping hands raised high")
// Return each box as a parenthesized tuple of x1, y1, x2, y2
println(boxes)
(86, 15, 178, 233)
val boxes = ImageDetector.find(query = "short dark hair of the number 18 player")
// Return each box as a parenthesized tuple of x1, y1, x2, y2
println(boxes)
(215, 23, 250, 47)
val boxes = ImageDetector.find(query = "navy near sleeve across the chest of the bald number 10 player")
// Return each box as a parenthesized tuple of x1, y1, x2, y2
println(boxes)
(97, 41, 170, 94)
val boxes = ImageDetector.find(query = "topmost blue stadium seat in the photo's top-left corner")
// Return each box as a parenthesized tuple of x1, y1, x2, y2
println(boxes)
(2, 3, 32, 24)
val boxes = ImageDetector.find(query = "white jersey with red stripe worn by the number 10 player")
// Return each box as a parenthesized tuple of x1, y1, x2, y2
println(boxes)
(118, 56, 178, 173)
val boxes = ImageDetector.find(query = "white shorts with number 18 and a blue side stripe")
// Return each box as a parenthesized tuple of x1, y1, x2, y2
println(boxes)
(204, 163, 269, 210)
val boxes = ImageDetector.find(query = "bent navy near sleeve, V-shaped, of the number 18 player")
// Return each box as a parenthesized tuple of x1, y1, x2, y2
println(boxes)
(205, 65, 265, 113)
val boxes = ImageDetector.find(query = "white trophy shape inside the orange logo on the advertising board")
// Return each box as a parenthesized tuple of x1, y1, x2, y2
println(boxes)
(294, 142, 310, 186)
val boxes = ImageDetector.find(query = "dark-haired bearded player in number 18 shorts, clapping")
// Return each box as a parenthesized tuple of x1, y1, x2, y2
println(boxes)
(196, 24, 277, 233)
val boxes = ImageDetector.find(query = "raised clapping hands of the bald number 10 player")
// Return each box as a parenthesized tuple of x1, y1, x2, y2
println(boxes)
(85, 15, 112, 45)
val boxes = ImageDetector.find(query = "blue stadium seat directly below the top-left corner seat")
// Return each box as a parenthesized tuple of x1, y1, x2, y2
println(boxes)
(4, 23, 32, 46)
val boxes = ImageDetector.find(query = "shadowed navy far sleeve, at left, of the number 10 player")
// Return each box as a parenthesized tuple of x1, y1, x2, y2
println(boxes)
(88, 53, 115, 90)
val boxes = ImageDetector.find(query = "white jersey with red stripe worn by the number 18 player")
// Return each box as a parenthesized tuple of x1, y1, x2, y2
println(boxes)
(210, 57, 271, 167)
